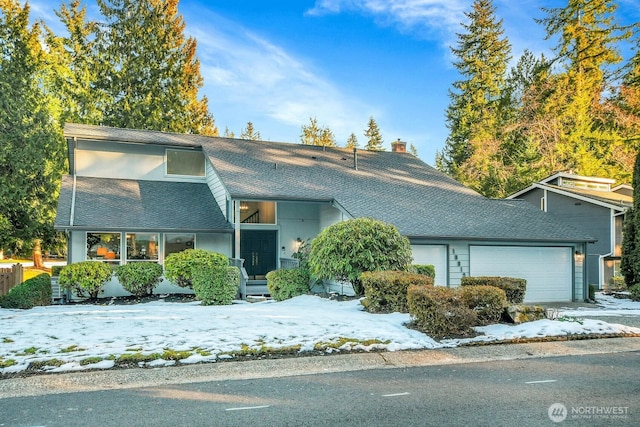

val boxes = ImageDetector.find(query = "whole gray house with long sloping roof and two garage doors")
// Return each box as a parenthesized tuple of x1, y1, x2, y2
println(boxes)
(55, 124, 593, 301)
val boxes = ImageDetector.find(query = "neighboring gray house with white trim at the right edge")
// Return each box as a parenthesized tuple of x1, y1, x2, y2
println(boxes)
(508, 172, 633, 288)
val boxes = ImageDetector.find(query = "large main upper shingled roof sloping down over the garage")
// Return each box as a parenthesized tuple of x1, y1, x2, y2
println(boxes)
(65, 125, 593, 242)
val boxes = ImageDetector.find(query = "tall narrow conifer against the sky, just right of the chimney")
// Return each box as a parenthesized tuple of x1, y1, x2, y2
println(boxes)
(436, 0, 511, 189)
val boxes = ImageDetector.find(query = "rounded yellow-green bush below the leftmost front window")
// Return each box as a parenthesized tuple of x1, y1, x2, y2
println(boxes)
(58, 261, 113, 299)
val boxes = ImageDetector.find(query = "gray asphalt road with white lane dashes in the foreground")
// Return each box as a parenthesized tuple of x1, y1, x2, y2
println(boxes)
(0, 346, 640, 427)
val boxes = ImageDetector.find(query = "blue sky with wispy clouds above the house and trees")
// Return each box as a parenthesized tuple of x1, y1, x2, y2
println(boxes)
(30, 0, 640, 164)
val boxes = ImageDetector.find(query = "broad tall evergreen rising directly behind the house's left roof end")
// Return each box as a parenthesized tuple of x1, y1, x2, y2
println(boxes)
(97, 0, 218, 135)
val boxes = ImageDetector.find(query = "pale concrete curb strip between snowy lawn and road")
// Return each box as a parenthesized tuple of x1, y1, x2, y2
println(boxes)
(0, 337, 640, 399)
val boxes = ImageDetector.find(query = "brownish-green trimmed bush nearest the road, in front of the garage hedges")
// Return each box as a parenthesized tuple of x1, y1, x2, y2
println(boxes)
(407, 285, 478, 338)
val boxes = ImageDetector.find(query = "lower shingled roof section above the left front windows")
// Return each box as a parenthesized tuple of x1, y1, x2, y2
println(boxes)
(55, 175, 232, 232)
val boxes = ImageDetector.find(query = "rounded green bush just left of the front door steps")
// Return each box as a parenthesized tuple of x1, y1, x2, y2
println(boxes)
(192, 266, 240, 305)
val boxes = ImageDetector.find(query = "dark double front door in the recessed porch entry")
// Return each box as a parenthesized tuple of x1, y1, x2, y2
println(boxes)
(240, 230, 277, 280)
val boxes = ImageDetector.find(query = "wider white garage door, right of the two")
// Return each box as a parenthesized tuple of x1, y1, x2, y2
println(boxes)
(470, 246, 573, 303)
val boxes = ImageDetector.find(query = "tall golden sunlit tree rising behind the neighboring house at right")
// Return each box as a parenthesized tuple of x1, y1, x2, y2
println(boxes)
(539, 0, 631, 177)
